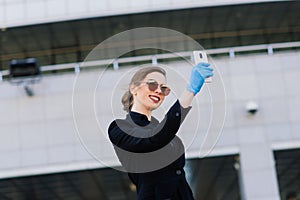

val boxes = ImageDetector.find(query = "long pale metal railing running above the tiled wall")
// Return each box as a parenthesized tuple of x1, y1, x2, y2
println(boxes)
(0, 42, 300, 81)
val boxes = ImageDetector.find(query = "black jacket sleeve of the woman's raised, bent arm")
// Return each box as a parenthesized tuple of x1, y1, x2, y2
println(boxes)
(108, 101, 190, 153)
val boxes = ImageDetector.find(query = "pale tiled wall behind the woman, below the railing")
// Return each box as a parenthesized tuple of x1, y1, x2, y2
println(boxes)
(0, 52, 300, 177)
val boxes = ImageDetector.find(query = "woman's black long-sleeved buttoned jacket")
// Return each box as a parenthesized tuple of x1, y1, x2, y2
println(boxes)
(108, 100, 194, 200)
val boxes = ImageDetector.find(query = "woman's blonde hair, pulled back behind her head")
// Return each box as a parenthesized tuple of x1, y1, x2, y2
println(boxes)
(122, 66, 166, 112)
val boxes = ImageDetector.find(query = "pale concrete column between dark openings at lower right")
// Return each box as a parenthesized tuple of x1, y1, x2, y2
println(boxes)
(239, 127, 280, 200)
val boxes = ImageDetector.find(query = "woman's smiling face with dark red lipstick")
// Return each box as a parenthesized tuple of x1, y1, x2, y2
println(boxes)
(132, 72, 166, 111)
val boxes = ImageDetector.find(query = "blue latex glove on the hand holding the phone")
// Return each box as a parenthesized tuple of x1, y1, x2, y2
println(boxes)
(187, 62, 213, 95)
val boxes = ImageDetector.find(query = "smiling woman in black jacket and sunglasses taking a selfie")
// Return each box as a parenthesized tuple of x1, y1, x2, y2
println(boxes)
(108, 63, 213, 200)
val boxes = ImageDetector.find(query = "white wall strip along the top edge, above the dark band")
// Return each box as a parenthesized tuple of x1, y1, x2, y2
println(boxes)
(0, 0, 271, 29)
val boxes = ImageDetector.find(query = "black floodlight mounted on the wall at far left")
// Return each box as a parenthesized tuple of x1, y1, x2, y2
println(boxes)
(9, 58, 41, 96)
